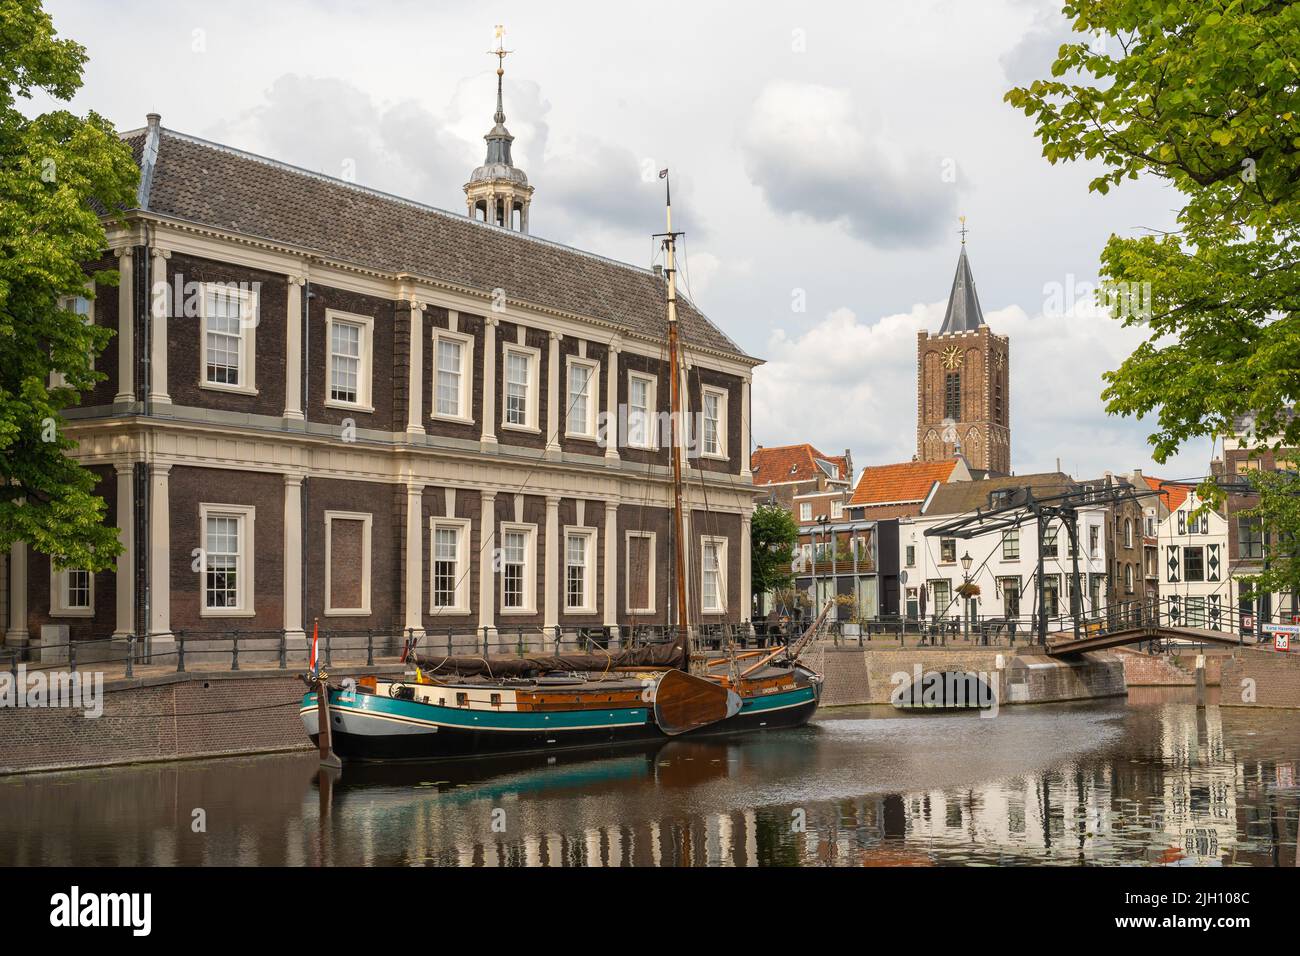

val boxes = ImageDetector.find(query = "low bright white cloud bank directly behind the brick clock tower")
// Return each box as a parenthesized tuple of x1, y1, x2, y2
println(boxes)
(753, 302, 1206, 477)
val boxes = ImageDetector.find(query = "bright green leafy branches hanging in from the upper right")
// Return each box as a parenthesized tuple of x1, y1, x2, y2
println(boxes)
(1006, 0, 1300, 462)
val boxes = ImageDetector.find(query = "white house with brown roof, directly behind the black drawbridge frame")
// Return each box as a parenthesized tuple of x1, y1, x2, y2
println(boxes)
(898, 472, 1108, 630)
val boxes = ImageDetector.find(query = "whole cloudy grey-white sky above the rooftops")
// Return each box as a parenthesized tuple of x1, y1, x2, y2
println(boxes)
(33, 0, 1210, 477)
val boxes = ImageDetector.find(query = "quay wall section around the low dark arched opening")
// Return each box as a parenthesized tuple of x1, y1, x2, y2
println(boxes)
(822, 646, 1127, 708)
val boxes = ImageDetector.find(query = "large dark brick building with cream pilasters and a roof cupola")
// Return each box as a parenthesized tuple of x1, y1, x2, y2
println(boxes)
(0, 94, 758, 658)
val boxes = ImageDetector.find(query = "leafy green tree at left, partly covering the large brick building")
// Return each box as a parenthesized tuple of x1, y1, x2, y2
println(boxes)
(0, 0, 138, 570)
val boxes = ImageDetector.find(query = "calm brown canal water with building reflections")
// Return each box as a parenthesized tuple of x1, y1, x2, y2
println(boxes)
(0, 689, 1300, 866)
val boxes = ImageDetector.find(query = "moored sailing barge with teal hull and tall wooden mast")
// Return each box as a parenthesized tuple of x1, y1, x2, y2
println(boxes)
(299, 169, 831, 765)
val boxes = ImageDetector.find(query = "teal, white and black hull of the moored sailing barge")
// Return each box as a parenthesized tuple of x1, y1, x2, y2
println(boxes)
(299, 684, 820, 761)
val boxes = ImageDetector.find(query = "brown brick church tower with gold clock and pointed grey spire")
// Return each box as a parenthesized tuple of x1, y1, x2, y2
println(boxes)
(917, 225, 1011, 475)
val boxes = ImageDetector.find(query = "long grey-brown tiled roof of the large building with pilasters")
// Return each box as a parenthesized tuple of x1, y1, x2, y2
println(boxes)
(122, 121, 744, 356)
